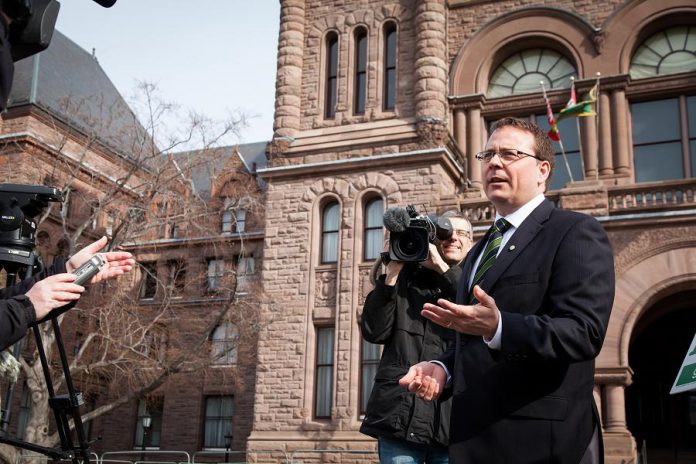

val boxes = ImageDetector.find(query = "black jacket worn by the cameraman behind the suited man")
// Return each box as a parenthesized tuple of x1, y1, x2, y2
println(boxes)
(360, 264, 462, 447)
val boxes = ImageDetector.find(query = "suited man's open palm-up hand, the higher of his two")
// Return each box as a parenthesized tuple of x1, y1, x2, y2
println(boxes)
(421, 285, 500, 339)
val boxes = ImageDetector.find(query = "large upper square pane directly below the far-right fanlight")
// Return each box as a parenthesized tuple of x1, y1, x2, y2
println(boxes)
(631, 98, 680, 145)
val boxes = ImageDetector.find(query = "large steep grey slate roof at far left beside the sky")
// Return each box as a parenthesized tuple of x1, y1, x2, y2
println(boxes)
(8, 31, 153, 157)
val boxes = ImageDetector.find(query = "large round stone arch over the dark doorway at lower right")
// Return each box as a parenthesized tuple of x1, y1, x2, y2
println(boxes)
(597, 244, 696, 367)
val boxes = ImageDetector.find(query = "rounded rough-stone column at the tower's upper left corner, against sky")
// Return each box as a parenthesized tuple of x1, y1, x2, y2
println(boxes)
(273, 0, 305, 138)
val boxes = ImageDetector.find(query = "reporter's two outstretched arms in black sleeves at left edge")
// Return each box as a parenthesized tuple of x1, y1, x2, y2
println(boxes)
(0, 237, 135, 351)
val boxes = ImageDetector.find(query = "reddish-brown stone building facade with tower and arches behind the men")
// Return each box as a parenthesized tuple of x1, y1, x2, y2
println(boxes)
(248, 0, 696, 463)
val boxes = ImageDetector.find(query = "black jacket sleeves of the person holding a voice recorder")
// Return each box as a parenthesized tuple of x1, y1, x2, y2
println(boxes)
(0, 257, 68, 350)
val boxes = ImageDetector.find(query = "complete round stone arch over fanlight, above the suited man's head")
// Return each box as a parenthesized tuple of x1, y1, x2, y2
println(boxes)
(450, 7, 596, 96)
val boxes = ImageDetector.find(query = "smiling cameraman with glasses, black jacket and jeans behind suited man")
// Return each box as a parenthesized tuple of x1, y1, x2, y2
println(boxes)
(360, 211, 473, 464)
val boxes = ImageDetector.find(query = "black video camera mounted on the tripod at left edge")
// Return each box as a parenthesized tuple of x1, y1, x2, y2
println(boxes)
(0, 184, 63, 266)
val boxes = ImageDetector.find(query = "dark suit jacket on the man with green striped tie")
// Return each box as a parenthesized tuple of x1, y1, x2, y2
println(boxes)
(440, 200, 614, 464)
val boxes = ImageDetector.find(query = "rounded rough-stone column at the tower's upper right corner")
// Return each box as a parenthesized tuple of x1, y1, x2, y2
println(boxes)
(414, 0, 447, 123)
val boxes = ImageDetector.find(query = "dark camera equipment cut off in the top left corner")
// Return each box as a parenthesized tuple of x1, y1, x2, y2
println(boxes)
(0, 0, 116, 111)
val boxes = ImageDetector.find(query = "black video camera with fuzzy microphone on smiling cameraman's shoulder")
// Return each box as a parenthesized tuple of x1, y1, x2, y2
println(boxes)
(382, 205, 452, 263)
